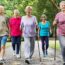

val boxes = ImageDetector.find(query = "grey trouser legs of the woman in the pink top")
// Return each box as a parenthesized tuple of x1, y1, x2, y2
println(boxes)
(58, 36, 65, 65)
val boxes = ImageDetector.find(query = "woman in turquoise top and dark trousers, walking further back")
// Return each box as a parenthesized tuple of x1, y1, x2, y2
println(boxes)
(38, 14, 50, 57)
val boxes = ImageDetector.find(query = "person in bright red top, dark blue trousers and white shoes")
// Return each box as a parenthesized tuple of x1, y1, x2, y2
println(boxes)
(9, 9, 21, 58)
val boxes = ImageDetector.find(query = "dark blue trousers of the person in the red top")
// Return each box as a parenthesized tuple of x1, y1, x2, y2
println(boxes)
(11, 36, 21, 54)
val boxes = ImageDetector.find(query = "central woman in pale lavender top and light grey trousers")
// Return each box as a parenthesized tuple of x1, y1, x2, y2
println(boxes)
(21, 6, 37, 64)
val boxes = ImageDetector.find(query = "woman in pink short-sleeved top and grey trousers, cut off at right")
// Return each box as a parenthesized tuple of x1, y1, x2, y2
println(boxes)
(53, 1, 65, 65)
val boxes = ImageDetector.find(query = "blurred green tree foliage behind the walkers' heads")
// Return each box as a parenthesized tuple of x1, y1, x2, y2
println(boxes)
(0, 0, 61, 22)
